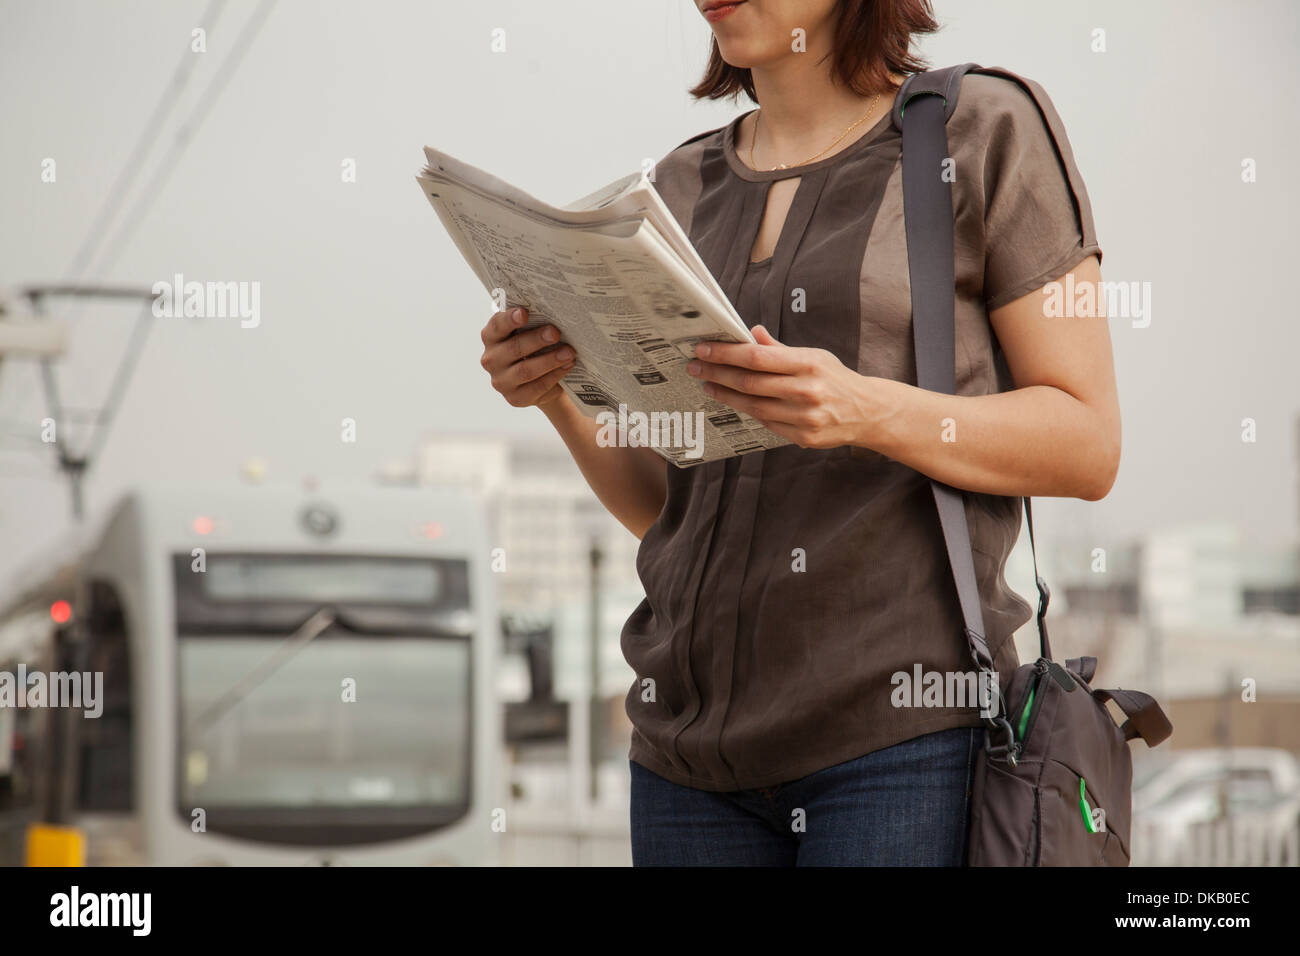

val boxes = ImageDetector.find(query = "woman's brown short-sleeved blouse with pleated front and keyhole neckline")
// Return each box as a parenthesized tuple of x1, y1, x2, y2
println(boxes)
(621, 74, 1100, 791)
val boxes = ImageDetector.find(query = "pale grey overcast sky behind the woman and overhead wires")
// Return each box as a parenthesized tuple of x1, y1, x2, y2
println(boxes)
(0, 0, 1300, 590)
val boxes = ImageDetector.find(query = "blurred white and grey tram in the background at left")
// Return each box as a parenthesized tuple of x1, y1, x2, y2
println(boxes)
(0, 486, 502, 865)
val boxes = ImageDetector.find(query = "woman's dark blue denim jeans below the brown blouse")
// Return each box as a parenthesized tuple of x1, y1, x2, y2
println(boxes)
(629, 727, 984, 866)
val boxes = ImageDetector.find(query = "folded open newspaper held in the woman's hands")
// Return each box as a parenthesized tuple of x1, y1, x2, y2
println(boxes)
(416, 147, 789, 468)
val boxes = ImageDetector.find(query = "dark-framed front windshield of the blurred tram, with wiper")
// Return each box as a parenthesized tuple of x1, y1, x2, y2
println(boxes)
(174, 554, 472, 845)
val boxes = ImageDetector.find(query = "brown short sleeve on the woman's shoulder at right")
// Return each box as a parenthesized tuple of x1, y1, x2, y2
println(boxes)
(962, 75, 1101, 310)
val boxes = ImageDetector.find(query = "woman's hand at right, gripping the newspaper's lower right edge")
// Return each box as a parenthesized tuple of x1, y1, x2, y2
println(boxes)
(686, 325, 871, 449)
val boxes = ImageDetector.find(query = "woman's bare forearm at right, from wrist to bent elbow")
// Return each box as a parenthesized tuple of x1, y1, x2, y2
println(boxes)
(854, 377, 1121, 501)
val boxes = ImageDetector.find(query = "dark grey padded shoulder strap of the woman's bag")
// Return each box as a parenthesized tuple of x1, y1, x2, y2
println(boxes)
(892, 64, 1052, 671)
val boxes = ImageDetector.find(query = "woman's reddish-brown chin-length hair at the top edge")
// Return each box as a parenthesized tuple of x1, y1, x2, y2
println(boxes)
(690, 0, 939, 103)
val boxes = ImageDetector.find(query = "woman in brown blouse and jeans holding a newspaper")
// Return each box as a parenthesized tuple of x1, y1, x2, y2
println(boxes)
(482, 0, 1119, 865)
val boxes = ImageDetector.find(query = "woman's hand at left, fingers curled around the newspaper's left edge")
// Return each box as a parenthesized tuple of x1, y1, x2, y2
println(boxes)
(478, 308, 575, 408)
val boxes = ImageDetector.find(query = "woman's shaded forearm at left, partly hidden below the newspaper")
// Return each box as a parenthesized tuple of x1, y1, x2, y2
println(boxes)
(541, 395, 668, 538)
